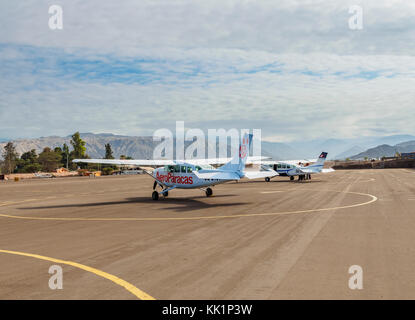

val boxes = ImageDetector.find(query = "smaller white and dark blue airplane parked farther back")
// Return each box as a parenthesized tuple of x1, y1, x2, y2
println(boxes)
(261, 152, 334, 182)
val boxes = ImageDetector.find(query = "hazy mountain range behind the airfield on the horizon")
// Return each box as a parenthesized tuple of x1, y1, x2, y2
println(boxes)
(0, 133, 415, 160)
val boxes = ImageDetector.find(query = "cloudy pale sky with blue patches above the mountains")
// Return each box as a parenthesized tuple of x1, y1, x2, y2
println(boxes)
(0, 0, 415, 141)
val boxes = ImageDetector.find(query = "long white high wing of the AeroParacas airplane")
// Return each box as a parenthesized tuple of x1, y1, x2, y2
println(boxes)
(73, 156, 268, 167)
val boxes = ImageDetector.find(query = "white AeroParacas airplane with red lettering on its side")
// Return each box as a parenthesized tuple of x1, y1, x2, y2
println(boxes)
(73, 134, 278, 200)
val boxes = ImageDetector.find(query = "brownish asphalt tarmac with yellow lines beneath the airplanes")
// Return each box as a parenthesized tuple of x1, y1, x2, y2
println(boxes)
(0, 169, 415, 299)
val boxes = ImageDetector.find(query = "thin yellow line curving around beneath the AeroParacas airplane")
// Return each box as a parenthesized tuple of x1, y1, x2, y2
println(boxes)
(0, 189, 378, 221)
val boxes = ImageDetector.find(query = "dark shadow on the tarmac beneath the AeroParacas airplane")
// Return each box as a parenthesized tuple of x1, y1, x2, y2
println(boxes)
(17, 194, 249, 212)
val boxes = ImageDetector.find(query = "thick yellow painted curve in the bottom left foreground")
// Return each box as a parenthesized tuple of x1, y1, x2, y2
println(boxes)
(0, 249, 155, 300)
